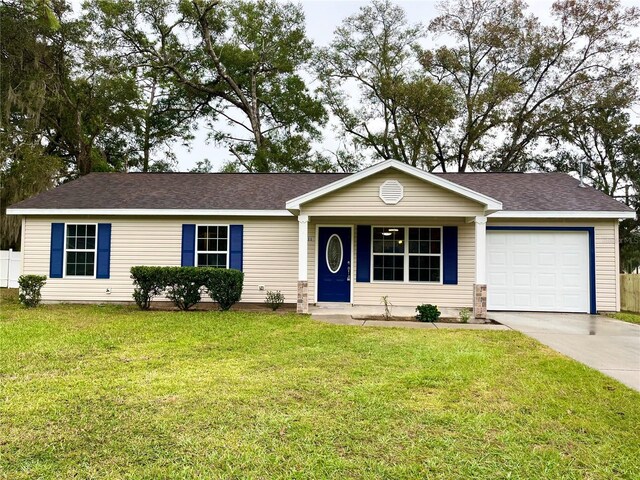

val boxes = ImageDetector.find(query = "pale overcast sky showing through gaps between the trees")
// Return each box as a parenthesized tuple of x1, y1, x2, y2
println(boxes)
(71, 0, 638, 171)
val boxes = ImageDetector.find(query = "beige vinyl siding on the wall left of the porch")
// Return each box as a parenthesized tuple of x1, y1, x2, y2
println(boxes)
(23, 217, 298, 303)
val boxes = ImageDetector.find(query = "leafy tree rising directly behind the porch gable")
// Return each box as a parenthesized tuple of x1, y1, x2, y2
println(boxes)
(315, 0, 456, 170)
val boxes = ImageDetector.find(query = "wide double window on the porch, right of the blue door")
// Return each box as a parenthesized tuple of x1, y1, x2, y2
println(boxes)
(372, 227, 442, 283)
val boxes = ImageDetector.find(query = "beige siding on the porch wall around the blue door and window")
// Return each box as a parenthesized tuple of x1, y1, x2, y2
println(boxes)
(308, 217, 475, 307)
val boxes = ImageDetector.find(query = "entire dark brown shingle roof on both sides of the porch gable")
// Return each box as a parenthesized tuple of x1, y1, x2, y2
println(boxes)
(12, 173, 629, 211)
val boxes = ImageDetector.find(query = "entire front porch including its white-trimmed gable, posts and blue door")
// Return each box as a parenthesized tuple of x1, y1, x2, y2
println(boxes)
(286, 161, 502, 318)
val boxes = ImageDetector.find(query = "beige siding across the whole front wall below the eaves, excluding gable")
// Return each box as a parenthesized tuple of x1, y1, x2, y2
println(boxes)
(22, 214, 620, 311)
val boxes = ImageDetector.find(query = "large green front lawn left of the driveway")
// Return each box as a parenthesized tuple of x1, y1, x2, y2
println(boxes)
(0, 292, 640, 480)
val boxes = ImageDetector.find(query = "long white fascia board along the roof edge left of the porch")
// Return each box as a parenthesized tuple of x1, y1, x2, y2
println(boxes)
(2, 208, 293, 217)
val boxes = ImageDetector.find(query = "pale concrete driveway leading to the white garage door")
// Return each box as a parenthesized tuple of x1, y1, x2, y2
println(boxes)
(489, 312, 640, 391)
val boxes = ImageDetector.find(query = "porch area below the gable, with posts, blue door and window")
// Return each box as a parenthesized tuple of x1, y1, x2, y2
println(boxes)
(297, 218, 486, 321)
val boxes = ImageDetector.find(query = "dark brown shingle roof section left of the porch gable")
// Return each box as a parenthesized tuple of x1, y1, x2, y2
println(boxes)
(8, 173, 346, 210)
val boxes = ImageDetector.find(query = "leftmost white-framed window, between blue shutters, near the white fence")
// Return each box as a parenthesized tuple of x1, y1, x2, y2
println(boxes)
(65, 223, 97, 277)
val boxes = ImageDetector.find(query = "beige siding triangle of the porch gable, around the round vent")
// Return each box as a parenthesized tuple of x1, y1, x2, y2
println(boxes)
(302, 169, 484, 217)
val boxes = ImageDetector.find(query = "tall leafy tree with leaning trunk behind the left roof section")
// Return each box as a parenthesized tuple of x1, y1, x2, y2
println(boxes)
(93, 0, 326, 172)
